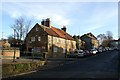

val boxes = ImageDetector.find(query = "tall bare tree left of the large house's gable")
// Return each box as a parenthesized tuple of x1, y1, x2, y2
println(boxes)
(11, 17, 31, 40)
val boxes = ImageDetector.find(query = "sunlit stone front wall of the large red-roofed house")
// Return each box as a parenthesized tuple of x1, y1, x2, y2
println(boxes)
(48, 35, 76, 57)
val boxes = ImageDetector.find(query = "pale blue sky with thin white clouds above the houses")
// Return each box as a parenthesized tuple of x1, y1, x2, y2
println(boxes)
(0, 0, 118, 39)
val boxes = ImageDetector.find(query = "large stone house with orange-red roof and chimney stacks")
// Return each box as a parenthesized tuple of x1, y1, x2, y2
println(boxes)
(25, 18, 76, 57)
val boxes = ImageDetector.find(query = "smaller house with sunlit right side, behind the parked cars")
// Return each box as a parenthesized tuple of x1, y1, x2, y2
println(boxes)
(81, 33, 99, 50)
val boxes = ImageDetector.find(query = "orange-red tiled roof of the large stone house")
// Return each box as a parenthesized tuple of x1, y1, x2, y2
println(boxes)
(39, 25, 74, 40)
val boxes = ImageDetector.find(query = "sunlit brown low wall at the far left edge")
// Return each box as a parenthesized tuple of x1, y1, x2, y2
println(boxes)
(2, 49, 20, 59)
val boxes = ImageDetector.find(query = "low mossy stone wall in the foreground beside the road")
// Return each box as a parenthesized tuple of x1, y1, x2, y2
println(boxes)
(2, 61, 46, 78)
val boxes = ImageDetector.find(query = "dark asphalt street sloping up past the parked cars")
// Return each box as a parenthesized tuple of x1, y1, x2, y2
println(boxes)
(3, 50, 118, 80)
